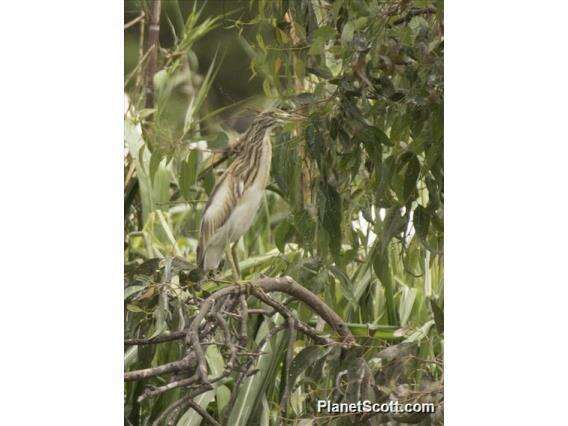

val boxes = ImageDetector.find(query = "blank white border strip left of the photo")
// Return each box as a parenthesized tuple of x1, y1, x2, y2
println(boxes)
(0, 0, 124, 426)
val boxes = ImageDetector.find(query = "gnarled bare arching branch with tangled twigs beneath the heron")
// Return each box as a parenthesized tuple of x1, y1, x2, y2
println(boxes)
(124, 277, 355, 424)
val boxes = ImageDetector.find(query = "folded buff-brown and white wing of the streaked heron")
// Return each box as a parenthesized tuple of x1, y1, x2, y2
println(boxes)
(197, 168, 244, 267)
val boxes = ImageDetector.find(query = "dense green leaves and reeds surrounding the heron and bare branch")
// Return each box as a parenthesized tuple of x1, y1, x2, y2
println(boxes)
(125, 0, 444, 425)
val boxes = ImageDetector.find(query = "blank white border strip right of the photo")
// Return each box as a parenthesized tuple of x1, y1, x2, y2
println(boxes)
(445, 0, 568, 426)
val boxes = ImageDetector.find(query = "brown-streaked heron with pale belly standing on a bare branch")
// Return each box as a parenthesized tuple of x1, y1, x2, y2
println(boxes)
(197, 109, 302, 276)
